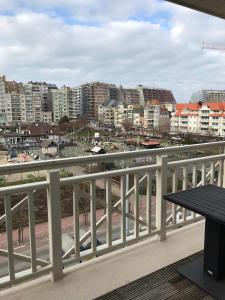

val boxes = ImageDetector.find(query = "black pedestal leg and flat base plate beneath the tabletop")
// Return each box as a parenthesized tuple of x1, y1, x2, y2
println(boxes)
(177, 219, 225, 300)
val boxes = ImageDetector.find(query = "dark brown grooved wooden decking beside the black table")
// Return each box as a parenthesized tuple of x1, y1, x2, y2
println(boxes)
(95, 253, 214, 300)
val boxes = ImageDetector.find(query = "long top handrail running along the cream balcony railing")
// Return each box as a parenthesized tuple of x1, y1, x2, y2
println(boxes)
(0, 141, 225, 175)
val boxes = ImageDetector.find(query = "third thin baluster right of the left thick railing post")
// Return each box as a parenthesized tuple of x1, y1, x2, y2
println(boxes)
(106, 178, 112, 247)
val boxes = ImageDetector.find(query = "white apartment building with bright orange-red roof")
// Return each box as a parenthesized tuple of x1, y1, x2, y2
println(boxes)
(171, 102, 225, 136)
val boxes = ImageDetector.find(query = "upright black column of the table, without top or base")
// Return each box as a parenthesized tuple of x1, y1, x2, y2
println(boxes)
(203, 219, 225, 280)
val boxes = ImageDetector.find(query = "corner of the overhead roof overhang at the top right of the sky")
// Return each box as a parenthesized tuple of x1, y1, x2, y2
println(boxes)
(166, 0, 225, 19)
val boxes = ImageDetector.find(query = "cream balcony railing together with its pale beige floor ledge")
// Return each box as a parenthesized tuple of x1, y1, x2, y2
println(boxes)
(0, 142, 225, 299)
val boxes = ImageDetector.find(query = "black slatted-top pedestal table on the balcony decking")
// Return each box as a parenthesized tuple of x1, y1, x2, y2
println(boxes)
(164, 184, 225, 299)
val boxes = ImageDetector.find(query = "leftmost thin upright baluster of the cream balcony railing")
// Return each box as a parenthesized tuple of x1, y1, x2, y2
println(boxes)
(4, 195, 15, 280)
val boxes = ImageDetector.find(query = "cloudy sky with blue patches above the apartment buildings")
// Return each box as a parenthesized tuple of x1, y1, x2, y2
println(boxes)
(0, 0, 225, 102)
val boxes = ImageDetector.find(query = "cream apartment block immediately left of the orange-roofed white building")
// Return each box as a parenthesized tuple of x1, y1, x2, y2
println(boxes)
(144, 105, 170, 131)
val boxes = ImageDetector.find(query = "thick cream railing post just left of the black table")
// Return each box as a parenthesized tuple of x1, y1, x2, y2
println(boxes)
(156, 155, 167, 241)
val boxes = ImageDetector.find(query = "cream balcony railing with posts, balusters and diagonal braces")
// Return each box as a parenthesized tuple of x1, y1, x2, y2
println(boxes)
(0, 142, 225, 286)
